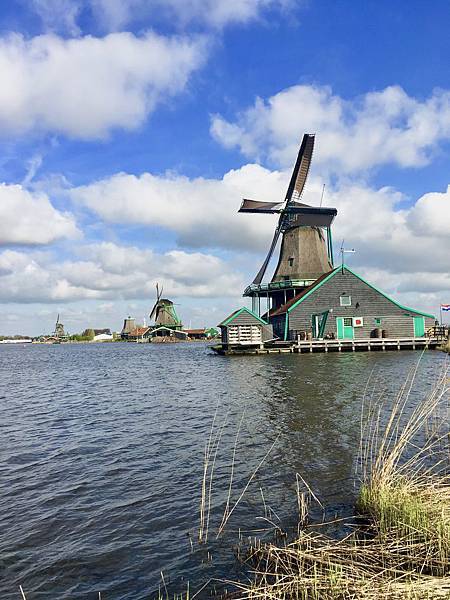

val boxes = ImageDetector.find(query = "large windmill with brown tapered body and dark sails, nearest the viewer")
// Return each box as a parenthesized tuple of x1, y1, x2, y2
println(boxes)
(239, 133, 337, 314)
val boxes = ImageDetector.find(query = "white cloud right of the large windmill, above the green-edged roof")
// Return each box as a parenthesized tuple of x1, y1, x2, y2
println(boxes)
(326, 183, 450, 282)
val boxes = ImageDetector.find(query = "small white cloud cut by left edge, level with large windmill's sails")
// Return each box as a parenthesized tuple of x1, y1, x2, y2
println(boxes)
(0, 183, 80, 246)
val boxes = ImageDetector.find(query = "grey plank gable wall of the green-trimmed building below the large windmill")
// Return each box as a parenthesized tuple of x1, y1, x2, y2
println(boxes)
(273, 271, 434, 339)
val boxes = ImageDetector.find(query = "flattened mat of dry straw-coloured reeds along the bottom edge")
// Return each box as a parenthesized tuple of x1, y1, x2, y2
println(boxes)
(237, 533, 450, 600)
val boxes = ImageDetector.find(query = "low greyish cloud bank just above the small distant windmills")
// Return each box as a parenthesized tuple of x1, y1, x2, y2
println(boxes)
(0, 242, 244, 303)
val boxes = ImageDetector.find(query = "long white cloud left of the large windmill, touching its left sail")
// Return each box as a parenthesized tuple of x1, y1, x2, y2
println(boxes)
(71, 165, 288, 250)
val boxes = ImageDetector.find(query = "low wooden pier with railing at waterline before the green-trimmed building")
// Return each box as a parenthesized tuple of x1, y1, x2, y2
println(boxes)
(213, 337, 443, 355)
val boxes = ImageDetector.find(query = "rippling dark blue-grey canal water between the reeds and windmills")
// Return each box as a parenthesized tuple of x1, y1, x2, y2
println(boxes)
(0, 343, 445, 600)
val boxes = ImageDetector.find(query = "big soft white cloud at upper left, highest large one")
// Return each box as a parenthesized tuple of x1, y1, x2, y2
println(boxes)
(0, 32, 205, 140)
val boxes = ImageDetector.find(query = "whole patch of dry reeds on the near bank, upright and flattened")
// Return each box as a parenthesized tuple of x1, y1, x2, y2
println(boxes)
(232, 358, 450, 600)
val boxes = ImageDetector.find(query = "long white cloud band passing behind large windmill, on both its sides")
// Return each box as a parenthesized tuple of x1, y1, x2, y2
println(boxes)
(71, 164, 450, 316)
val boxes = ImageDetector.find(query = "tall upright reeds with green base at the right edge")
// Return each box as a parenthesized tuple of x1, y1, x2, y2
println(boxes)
(357, 358, 450, 575)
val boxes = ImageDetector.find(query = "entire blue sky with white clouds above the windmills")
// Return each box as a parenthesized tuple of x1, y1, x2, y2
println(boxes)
(0, 0, 450, 335)
